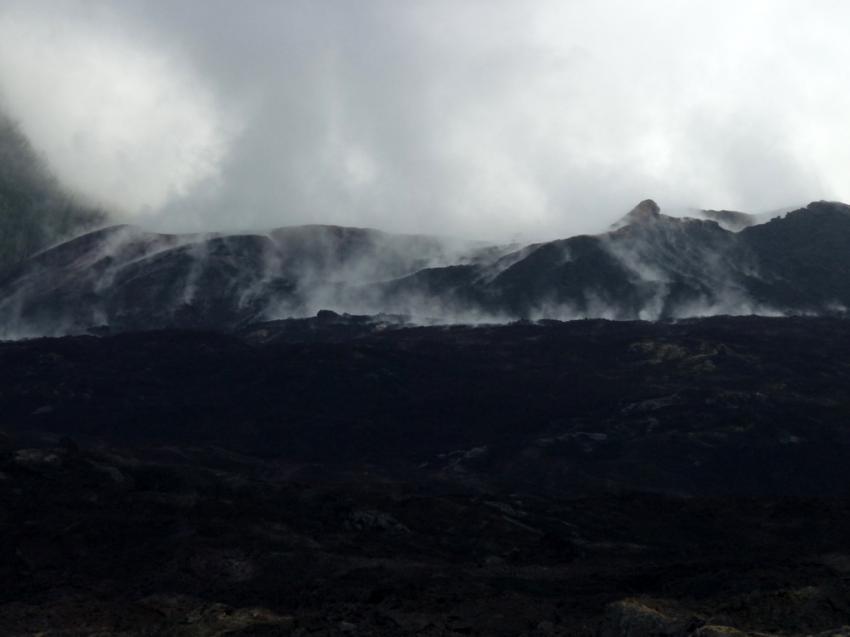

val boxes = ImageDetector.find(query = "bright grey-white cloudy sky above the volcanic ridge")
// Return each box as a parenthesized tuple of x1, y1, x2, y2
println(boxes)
(0, 0, 850, 238)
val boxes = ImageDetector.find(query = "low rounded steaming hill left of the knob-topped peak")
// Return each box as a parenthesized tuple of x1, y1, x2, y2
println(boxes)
(0, 221, 504, 338)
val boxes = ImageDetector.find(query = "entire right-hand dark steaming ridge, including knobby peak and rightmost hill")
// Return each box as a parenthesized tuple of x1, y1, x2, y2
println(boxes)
(388, 200, 850, 320)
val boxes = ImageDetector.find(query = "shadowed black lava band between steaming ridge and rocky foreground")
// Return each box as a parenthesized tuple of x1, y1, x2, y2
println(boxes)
(0, 315, 850, 496)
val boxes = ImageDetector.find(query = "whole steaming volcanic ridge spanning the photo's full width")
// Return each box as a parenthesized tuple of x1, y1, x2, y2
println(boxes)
(0, 200, 850, 338)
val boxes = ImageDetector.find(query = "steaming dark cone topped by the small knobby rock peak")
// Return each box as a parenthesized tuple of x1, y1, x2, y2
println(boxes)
(476, 201, 754, 319)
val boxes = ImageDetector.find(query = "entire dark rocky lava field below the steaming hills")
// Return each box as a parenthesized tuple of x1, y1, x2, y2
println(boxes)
(0, 312, 850, 637)
